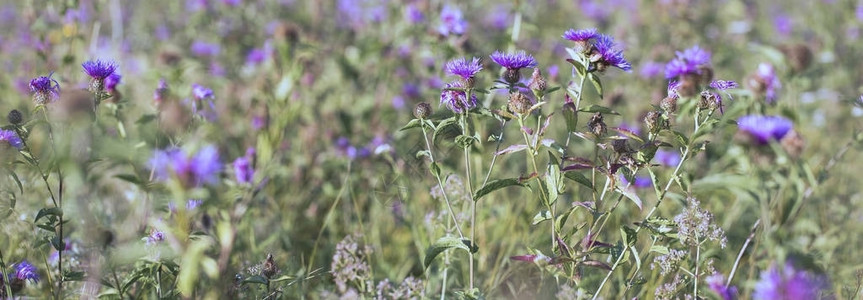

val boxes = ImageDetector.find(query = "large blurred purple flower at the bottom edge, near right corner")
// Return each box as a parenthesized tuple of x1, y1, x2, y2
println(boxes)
(752, 263, 830, 300)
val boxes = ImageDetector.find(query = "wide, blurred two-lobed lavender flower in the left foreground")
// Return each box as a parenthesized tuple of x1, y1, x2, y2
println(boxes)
(150, 145, 222, 187)
